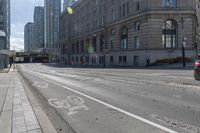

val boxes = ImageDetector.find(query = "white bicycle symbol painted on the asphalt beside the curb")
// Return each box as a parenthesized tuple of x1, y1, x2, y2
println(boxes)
(48, 96, 90, 115)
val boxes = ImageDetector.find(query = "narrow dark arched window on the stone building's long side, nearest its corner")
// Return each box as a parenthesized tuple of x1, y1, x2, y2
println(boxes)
(120, 27, 128, 50)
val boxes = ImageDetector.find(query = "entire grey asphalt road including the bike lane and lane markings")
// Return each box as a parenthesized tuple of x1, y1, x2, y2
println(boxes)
(16, 64, 200, 133)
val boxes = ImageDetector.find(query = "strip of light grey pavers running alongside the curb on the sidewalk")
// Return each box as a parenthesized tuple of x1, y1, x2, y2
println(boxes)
(13, 77, 42, 133)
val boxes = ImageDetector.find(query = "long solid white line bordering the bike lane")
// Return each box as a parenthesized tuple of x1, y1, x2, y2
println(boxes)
(25, 70, 178, 133)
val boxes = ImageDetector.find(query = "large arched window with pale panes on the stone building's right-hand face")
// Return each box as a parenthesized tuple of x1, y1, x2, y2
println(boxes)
(162, 20, 177, 48)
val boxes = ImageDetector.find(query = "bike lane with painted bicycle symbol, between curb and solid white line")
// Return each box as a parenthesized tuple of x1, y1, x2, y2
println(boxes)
(16, 65, 181, 133)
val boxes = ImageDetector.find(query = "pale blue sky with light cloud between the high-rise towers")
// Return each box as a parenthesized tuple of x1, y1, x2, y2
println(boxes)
(10, 0, 44, 50)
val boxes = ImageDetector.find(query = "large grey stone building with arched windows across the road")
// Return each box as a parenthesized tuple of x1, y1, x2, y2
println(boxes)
(60, 0, 200, 66)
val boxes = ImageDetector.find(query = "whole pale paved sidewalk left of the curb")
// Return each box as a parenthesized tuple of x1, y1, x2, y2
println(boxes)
(0, 68, 55, 133)
